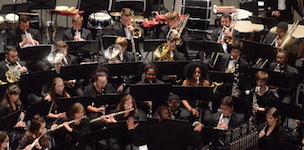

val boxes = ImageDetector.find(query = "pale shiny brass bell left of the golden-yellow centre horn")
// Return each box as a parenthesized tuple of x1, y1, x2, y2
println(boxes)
(104, 44, 121, 63)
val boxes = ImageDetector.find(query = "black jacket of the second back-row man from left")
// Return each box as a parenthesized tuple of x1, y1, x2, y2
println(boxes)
(63, 27, 93, 41)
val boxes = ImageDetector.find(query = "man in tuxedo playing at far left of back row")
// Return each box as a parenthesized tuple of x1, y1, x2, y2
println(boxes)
(6, 15, 41, 49)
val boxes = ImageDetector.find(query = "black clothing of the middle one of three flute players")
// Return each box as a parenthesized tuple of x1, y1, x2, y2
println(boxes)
(54, 118, 90, 149)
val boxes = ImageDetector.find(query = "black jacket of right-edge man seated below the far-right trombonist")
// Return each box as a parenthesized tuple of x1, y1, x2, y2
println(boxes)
(269, 62, 299, 103)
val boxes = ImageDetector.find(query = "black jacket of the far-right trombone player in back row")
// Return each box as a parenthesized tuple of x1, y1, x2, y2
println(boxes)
(264, 32, 299, 66)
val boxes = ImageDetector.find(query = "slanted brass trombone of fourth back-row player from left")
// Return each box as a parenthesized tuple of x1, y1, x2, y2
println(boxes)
(167, 14, 190, 46)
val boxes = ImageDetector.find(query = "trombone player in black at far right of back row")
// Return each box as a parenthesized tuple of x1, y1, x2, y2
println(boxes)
(264, 21, 299, 66)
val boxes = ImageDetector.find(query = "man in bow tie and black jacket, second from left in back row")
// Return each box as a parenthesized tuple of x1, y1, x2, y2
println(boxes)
(63, 14, 92, 41)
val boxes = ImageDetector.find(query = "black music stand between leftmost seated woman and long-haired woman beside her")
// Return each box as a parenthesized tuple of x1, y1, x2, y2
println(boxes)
(24, 101, 53, 121)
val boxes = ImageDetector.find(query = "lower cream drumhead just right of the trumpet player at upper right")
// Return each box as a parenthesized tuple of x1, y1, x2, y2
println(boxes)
(235, 20, 264, 33)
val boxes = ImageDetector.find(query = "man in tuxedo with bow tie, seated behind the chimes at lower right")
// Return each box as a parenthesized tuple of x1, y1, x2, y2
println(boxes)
(209, 96, 245, 130)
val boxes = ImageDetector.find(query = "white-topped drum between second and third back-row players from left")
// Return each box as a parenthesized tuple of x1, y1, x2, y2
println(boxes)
(88, 12, 113, 29)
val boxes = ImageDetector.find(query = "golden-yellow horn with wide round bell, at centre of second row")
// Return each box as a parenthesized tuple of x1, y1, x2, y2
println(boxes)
(154, 43, 174, 61)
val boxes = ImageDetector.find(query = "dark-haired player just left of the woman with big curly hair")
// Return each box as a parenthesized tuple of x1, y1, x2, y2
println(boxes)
(136, 64, 164, 85)
